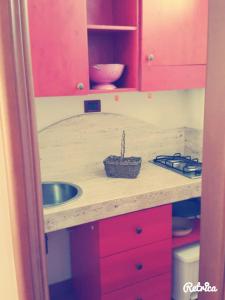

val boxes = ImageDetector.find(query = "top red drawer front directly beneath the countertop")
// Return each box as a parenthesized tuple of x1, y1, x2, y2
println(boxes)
(99, 205, 172, 257)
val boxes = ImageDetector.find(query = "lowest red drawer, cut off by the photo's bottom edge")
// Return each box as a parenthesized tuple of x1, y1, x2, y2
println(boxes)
(102, 273, 171, 300)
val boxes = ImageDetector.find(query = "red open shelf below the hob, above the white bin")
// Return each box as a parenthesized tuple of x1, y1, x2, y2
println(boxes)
(172, 219, 200, 248)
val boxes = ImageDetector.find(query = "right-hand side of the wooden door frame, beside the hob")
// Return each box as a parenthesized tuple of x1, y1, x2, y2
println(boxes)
(200, 0, 225, 300)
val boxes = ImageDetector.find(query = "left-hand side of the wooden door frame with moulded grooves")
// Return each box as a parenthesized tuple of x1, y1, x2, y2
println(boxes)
(0, 0, 49, 300)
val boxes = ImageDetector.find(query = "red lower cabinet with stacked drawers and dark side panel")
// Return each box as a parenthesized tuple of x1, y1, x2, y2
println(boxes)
(71, 205, 172, 300)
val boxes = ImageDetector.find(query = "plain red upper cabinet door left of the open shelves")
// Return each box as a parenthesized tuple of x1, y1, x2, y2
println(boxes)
(28, 0, 89, 96)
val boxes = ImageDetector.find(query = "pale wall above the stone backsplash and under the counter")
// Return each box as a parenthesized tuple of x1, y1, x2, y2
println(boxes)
(35, 90, 204, 284)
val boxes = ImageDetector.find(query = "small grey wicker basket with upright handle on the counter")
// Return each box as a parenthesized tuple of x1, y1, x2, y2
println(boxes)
(103, 131, 141, 178)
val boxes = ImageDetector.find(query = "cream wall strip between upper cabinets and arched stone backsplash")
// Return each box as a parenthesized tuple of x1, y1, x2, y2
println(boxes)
(36, 90, 204, 129)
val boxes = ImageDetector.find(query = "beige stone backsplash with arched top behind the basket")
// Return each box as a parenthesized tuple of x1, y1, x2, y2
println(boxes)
(39, 113, 184, 181)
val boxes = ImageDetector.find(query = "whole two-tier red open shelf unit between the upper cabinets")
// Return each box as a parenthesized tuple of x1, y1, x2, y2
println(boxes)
(86, 0, 139, 94)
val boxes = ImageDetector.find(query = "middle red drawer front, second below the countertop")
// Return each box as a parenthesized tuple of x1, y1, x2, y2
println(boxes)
(100, 240, 172, 294)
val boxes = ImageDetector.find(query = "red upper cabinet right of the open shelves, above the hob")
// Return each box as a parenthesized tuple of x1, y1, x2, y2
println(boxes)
(141, 0, 208, 90)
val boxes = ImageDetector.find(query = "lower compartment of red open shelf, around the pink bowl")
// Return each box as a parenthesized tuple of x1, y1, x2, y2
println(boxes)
(88, 30, 138, 93)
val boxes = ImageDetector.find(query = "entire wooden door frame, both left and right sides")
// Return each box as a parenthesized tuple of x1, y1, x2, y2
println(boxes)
(0, 0, 225, 300)
